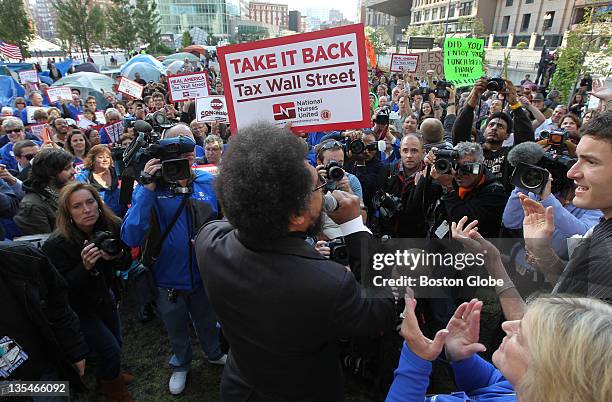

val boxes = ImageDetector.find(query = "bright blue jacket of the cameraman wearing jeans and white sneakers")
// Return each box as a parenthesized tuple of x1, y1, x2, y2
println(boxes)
(121, 171, 217, 290)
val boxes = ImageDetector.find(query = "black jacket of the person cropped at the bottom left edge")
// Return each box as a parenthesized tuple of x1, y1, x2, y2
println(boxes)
(0, 242, 89, 388)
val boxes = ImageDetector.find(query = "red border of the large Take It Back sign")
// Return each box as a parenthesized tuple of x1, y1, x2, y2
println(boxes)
(217, 23, 372, 133)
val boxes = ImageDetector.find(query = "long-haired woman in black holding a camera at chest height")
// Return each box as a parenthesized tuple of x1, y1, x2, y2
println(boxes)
(42, 183, 133, 402)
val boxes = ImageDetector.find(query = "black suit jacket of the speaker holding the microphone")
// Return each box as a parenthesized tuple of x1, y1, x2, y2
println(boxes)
(196, 221, 395, 402)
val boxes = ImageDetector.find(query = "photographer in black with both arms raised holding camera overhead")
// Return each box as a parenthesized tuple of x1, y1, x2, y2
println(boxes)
(453, 77, 534, 193)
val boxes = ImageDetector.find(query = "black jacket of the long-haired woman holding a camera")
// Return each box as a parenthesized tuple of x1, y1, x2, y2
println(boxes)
(42, 221, 131, 317)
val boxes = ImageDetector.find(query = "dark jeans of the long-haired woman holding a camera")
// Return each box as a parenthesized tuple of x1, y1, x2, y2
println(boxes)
(79, 310, 122, 381)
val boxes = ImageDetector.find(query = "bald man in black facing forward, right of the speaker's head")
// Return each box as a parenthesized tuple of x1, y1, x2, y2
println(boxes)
(375, 134, 427, 238)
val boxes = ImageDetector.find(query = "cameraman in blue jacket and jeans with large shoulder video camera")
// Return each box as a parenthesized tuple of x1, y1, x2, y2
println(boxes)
(121, 124, 225, 395)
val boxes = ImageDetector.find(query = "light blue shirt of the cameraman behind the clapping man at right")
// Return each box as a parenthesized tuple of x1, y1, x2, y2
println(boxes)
(502, 188, 603, 260)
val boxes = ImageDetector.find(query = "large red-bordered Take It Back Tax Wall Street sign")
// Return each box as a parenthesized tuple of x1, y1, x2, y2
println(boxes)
(217, 24, 371, 132)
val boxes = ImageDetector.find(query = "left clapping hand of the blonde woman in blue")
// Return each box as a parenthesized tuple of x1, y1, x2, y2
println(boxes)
(400, 295, 449, 361)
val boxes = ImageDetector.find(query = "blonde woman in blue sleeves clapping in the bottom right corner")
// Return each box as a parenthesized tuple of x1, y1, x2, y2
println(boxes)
(387, 295, 612, 402)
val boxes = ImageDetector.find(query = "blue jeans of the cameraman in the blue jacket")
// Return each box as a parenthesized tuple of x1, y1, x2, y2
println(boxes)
(156, 286, 223, 371)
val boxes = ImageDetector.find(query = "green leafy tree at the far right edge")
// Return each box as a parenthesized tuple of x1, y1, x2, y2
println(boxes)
(551, 9, 612, 102)
